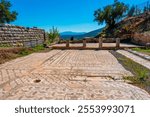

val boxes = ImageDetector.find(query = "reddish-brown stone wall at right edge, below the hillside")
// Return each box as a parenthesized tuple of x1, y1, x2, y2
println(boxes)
(131, 32, 150, 46)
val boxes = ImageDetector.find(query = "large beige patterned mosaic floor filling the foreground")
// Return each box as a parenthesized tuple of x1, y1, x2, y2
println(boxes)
(0, 50, 150, 100)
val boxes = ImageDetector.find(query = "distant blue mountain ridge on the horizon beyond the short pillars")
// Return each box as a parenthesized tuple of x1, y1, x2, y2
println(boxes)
(60, 28, 103, 39)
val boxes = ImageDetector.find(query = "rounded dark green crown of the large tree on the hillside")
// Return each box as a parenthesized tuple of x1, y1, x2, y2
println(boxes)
(94, 0, 128, 27)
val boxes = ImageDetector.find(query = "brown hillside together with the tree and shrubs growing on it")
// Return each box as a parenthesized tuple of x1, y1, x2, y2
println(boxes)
(94, 0, 150, 39)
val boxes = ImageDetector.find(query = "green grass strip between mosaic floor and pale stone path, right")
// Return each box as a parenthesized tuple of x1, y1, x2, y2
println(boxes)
(111, 51, 150, 93)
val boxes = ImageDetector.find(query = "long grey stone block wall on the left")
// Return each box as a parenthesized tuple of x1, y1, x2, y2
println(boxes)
(0, 25, 45, 47)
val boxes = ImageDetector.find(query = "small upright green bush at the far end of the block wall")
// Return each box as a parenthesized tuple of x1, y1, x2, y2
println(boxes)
(49, 27, 60, 42)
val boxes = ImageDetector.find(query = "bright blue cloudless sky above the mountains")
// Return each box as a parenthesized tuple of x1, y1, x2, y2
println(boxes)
(10, 0, 146, 32)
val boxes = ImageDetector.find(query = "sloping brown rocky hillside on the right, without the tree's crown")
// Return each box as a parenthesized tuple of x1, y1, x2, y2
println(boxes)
(97, 12, 150, 38)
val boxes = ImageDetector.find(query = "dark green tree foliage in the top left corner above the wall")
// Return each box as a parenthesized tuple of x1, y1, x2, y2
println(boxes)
(0, 0, 18, 24)
